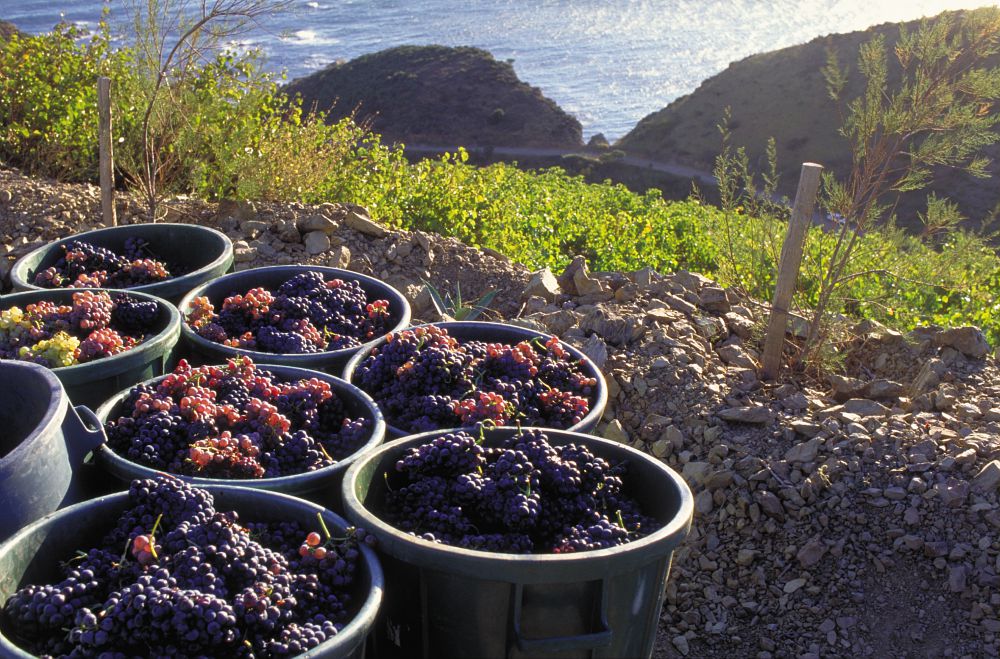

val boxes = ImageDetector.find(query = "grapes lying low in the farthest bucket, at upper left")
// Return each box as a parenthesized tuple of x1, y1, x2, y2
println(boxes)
(35, 237, 174, 288)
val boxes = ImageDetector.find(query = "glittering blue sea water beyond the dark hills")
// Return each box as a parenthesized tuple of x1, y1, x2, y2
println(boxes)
(0, 0, 989, 139)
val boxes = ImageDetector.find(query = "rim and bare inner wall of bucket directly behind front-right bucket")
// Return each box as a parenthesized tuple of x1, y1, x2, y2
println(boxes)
(344, 320, 608, 439)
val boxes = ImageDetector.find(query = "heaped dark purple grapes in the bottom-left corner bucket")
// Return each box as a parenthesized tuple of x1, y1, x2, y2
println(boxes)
(2, 477, 365, 657)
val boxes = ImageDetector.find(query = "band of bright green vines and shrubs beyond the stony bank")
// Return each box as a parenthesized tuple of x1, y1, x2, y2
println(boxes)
(0, 15, 1000, 341)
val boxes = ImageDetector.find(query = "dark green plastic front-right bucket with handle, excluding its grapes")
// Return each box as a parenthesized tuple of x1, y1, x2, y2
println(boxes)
(344, 428, 694, 658)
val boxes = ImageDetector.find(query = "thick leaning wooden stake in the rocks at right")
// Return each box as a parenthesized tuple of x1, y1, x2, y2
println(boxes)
(761, 162, 823, 380)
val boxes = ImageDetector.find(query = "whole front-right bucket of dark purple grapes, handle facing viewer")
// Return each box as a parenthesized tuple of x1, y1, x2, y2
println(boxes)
(344, 428, 694, 657)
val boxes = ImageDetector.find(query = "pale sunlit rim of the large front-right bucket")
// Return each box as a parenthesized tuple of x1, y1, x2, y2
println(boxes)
(343, 427, 694, 582)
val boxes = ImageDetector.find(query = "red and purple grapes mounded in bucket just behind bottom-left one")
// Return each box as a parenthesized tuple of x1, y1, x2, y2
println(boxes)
(105, 358, 372, 478)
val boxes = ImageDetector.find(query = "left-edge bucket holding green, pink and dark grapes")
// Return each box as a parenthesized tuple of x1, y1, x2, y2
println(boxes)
(0, 289, 180, 407)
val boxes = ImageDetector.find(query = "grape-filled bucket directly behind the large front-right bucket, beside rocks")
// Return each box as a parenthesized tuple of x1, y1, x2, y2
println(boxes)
(344, 322, 608, 437)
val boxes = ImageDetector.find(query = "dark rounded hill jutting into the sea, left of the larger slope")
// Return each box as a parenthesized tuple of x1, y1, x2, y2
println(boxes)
(286, 46, 582, 148)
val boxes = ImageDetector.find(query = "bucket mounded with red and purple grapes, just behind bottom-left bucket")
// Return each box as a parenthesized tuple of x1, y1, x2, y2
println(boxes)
(95, 357, 385, 509)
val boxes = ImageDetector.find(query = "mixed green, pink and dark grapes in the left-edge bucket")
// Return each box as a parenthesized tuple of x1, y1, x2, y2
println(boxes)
(0, 291, 159, 368)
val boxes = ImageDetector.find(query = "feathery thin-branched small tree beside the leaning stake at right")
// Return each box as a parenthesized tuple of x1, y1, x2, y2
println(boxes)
(799, 7, 1000, 361)
